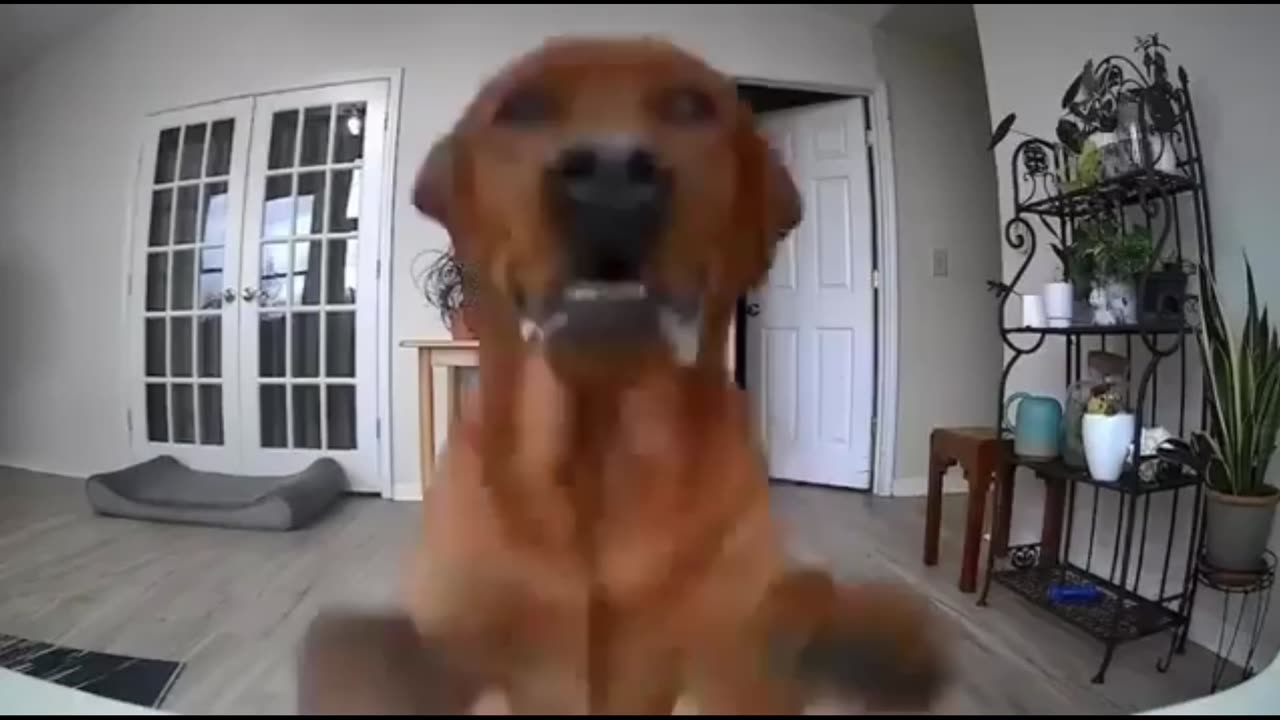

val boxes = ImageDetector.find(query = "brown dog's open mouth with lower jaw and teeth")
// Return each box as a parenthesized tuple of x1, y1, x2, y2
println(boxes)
(520, 281, 701, 365)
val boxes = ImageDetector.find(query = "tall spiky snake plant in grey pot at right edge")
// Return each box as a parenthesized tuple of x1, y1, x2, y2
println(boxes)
(1193, 259, 1280, 570)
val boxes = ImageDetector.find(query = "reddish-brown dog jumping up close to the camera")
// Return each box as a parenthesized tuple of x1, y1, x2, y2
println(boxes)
(300, 38, 945, 714)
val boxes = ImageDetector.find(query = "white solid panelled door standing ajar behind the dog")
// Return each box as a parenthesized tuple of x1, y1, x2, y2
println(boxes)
(746, 99, 874, 489)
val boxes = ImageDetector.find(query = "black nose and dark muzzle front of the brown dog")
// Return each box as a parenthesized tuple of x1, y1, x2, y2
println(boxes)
(552, 142, 669, 281)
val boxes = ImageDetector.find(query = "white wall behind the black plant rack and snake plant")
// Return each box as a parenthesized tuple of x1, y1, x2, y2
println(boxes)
(974, 4, 1280, 664)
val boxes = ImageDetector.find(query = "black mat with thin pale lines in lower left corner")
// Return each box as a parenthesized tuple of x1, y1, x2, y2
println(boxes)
(0, 633, 183, 708)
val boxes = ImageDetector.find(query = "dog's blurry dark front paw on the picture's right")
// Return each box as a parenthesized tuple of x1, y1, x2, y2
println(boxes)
(762, 573, 947, 711)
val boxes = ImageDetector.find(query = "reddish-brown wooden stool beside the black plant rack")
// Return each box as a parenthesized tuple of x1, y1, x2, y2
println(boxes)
(924, 428, 1014, 592)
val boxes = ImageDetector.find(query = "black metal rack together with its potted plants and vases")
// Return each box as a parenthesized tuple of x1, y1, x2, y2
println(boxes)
(979, 36, 1213, 683)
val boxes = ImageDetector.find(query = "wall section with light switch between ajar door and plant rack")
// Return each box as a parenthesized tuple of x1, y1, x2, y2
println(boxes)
(874, 32, 1001, 486)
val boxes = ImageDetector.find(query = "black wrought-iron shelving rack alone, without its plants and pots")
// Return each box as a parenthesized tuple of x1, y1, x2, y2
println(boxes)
(979, 44, 1213, 683)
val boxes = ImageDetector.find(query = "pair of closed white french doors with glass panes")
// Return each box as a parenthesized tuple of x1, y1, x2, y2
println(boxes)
(131, 81, 389, 491)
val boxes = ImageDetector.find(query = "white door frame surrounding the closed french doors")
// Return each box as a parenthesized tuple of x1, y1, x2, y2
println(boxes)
(118, 68, 404, 498)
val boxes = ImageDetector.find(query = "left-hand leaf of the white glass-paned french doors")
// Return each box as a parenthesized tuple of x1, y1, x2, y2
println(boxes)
(128, 100, 253, 470)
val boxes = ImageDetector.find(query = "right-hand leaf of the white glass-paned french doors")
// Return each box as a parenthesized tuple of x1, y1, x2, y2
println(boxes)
(238, 82, 389, 491)
